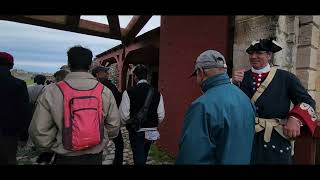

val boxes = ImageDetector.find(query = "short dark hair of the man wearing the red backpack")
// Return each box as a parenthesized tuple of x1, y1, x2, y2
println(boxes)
(67, 46, 93, 71)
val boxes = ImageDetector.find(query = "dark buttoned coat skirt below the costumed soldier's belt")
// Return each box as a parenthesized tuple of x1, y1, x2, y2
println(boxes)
(251, 130, 292, 164)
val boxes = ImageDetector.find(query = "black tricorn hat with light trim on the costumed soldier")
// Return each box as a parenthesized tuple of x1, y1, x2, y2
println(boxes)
(246, 38, 282, 54)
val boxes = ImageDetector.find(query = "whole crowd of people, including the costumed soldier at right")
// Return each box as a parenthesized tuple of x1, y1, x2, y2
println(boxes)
(0, 39, 318, 165)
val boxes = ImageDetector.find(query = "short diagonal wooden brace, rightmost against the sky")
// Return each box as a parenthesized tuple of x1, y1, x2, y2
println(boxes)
(124, 16, 152, 43)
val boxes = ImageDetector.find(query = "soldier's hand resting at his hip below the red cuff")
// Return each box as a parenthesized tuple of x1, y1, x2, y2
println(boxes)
(283, 116, 301, 139)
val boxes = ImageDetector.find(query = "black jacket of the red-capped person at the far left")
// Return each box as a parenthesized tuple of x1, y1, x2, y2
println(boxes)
(0, 67, 32, 136)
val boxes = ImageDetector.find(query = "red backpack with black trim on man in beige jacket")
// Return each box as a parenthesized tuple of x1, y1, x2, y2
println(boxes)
(57, 81, 104, 151)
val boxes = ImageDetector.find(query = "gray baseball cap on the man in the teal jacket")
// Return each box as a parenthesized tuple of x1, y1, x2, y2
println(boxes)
(190, 50, 227, 77)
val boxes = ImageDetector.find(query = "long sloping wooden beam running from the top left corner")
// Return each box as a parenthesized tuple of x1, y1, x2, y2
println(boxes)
(0, 16, 121, 40)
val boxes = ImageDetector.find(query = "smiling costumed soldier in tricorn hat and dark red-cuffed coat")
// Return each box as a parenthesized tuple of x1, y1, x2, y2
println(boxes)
(232, 39, 317, 164)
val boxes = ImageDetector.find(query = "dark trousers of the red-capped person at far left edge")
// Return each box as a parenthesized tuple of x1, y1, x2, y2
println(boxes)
(0, 135, 18, 165)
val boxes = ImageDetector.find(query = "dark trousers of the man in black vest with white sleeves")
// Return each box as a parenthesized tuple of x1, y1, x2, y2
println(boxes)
(129, 131, 152, 165)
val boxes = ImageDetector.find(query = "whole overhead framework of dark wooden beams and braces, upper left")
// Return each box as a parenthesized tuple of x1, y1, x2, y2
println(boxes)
(0, 15, 152, 44)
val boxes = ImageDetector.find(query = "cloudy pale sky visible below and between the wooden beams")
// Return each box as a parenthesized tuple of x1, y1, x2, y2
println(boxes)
(0, 16, 160, 73)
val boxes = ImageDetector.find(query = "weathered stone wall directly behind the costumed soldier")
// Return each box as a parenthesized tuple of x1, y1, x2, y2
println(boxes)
(233, 16, 320, 112)
